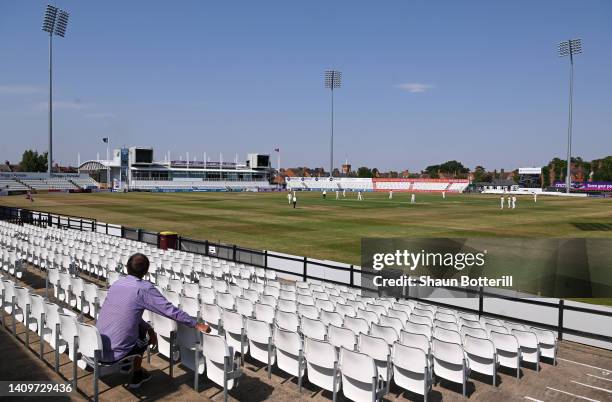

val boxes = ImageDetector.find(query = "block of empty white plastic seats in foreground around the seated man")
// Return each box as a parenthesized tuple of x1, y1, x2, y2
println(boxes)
(0, 222, 557, 400)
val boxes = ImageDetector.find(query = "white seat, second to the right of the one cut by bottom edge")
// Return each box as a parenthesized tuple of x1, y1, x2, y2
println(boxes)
(432, 336, 470, 396)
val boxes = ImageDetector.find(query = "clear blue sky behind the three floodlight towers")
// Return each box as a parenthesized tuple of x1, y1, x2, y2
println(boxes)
(0, 0, 612, 170)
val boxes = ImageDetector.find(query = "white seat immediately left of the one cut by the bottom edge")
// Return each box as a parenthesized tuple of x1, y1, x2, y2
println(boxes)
(304, 336, 342, 401)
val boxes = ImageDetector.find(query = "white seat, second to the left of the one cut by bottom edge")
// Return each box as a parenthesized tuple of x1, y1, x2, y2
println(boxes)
(274, 327, 306, 391)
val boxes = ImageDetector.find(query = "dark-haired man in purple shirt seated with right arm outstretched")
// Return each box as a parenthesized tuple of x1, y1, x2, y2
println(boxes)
(96, 253, 210, 388)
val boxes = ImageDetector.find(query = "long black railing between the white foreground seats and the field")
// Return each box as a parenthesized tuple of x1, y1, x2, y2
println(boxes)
(0, 206, 612, 343)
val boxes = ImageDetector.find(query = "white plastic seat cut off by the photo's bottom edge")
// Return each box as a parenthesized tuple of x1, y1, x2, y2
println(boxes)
(340, 348, 385, 402)
